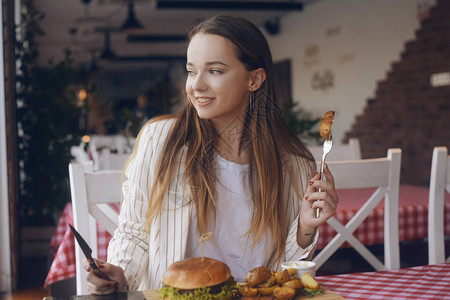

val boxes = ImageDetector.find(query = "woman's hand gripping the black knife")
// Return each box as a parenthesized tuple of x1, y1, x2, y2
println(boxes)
(83, 258, 128, 295)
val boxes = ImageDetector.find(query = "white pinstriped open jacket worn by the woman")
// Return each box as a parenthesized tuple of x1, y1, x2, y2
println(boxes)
(108, 119, 318, 290)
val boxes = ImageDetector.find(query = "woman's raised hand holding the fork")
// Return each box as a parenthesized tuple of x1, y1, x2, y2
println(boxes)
(300, 164, 339, 231)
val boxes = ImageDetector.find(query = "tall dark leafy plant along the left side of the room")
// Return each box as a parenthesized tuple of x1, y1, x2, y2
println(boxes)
(16, 0, 81, 225)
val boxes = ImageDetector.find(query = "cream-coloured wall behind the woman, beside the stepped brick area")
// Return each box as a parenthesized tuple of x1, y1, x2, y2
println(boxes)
(266, 0, 435, 143)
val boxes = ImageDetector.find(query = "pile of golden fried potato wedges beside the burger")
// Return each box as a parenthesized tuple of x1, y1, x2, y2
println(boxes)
(238, 267, 323, 300)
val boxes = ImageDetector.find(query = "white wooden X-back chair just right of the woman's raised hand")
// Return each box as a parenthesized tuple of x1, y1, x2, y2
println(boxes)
(313, 149, 401, 270)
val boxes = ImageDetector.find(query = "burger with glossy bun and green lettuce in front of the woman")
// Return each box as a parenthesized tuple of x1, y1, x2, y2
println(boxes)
(159, 257, 236, 300)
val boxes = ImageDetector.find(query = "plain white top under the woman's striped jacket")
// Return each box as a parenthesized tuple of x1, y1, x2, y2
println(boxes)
(186, 156, 268, 282)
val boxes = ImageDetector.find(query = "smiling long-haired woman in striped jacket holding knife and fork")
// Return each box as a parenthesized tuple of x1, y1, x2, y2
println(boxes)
(86, 16, 338, 294)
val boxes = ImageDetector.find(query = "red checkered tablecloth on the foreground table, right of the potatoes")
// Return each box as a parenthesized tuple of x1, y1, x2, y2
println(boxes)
(316, 263, 450, 300)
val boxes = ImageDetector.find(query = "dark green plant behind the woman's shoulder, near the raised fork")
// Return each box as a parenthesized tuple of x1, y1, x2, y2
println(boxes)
(282, 99, 321, 144)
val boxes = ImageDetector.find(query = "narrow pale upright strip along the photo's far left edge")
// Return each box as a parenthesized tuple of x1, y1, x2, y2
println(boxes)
(0, 1, 12, 292)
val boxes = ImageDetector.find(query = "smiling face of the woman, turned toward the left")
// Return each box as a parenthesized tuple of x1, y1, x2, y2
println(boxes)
(186, 34, 252, 126)
